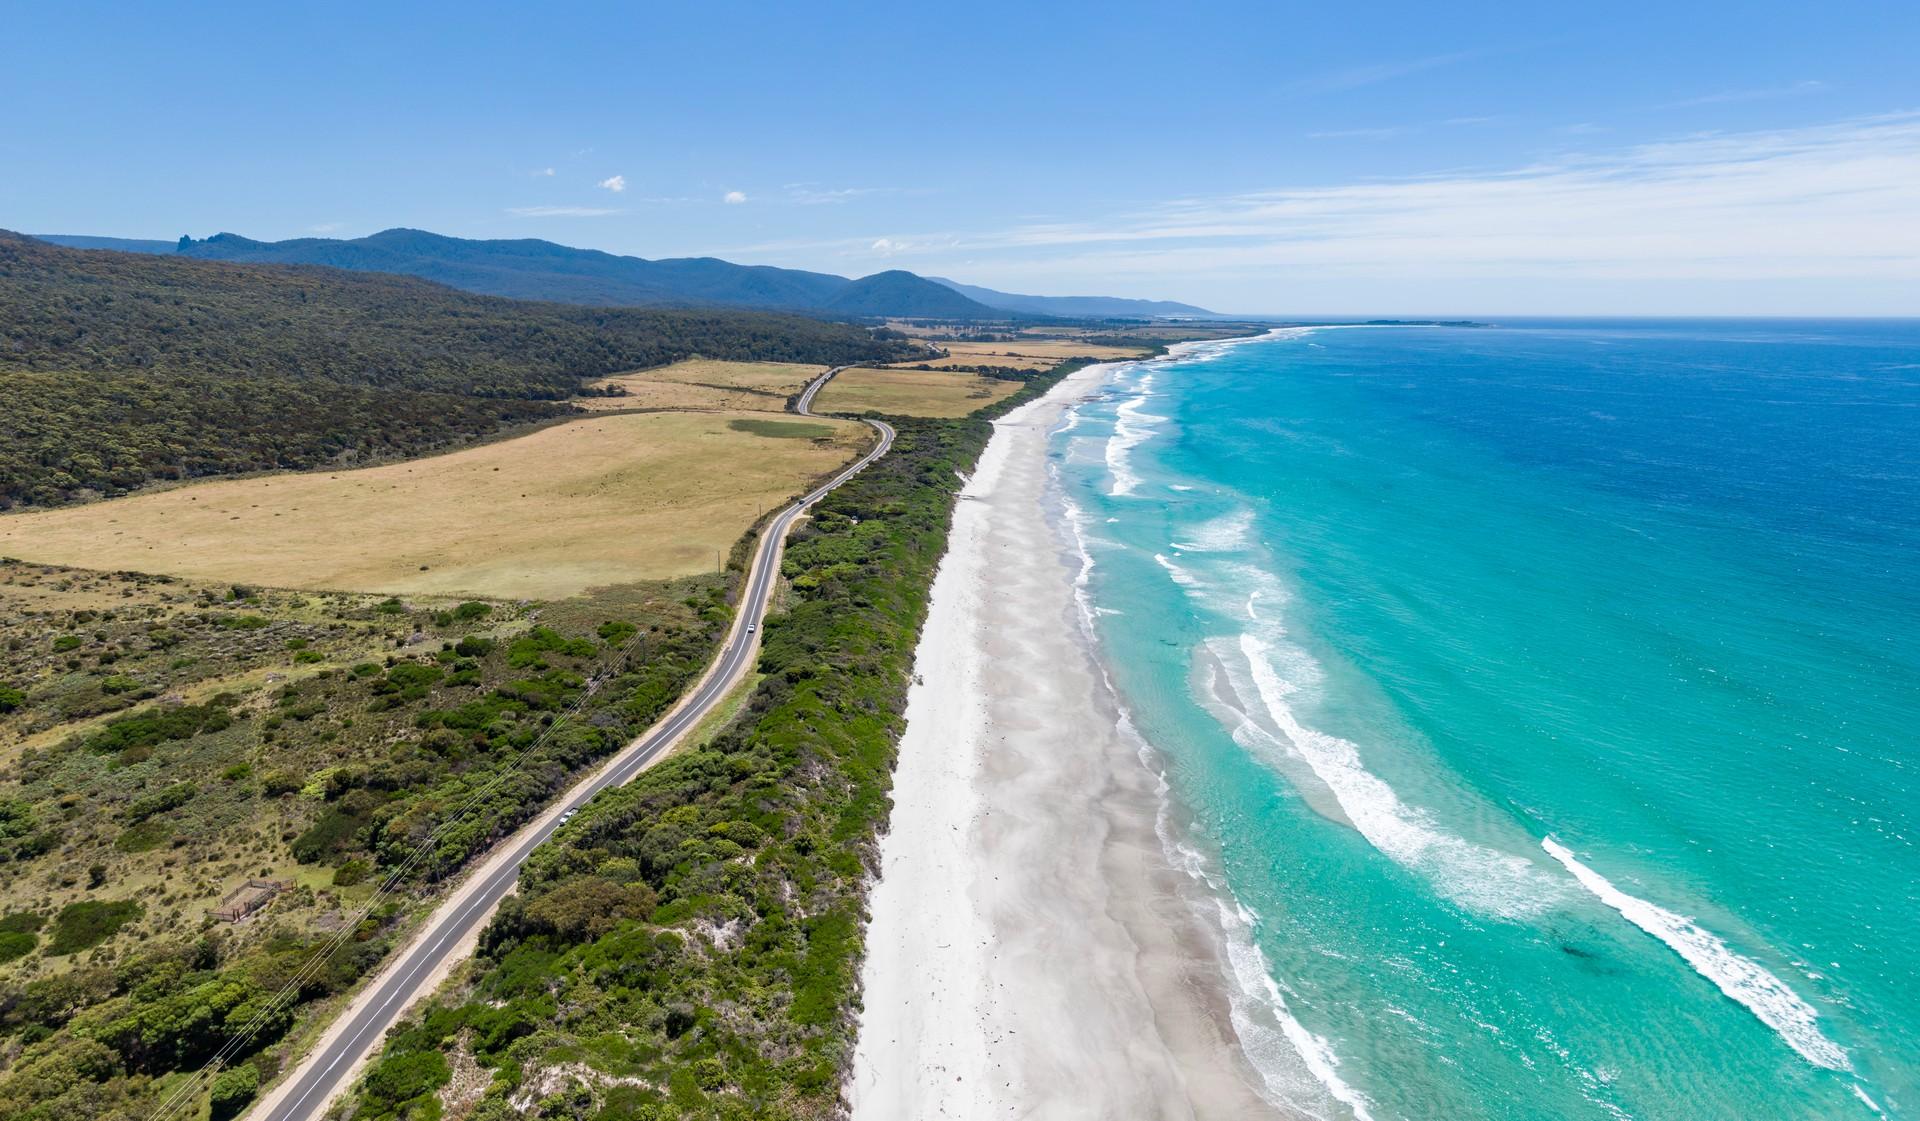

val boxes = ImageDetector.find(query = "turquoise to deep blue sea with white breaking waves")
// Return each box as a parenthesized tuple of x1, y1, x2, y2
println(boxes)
(1054, 322, 1920, 1121)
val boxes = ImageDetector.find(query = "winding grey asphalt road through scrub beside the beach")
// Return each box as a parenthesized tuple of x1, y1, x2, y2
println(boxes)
(248, 367, 893, 1121)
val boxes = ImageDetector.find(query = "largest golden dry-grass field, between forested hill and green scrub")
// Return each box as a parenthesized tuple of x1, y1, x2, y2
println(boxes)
(0, 410, 871, 599)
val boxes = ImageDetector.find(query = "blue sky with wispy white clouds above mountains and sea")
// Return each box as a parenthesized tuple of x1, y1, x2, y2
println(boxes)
(0, 0, 1920, 315)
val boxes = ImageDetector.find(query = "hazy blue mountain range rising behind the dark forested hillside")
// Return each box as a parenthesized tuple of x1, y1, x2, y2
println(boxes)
(161, 230, 1004, 319)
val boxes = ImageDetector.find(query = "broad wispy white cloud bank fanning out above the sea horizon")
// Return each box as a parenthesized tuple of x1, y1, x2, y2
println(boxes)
(741, 111, 1920, 292)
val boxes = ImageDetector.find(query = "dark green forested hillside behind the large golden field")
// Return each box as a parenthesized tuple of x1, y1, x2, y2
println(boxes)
(0, 232, 904, 509)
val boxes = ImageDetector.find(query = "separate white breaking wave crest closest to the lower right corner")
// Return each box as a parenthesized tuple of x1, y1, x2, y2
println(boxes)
(1540, 837, 1843, 1074)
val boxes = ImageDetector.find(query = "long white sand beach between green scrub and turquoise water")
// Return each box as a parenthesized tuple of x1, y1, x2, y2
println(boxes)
(847, 351, 1288, 1121)
